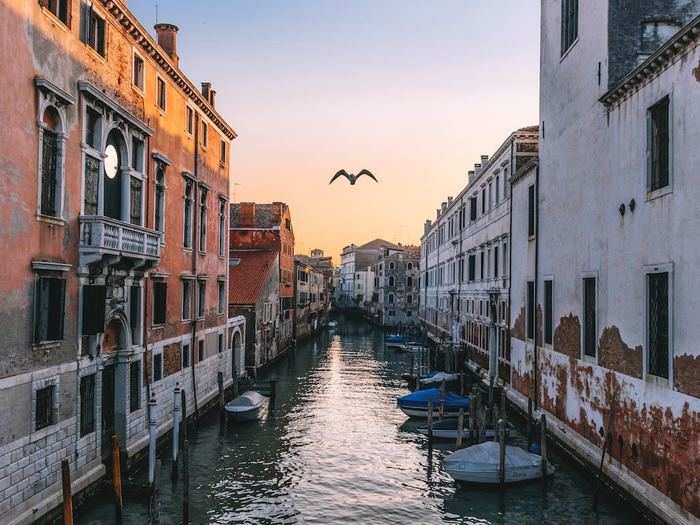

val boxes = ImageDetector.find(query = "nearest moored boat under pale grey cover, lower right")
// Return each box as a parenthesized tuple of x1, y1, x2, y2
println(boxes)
(445, 441, 554, 485)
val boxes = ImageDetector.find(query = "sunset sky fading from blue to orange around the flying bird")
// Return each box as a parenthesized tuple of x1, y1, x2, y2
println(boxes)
(129, 0, 539, 261)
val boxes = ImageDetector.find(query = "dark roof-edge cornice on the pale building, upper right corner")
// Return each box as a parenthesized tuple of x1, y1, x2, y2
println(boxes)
(600, 16, 700, 109)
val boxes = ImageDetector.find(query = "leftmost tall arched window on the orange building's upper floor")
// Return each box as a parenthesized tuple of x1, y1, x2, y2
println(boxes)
(39, 106, 63, 217)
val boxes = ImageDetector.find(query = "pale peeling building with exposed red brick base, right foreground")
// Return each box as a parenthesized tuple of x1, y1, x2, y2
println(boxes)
(511, 0, 700, 524)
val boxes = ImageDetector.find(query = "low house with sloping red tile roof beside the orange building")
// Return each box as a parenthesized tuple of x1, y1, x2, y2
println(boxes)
(229, 250, 280, 368)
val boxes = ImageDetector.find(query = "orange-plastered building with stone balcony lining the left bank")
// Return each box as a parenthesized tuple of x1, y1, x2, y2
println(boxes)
(0, 0, 236, 523)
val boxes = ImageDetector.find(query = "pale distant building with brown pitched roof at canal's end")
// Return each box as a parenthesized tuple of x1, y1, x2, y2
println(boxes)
(335, 239, 400, 309)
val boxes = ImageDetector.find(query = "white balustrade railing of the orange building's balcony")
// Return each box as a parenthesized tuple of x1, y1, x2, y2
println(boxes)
(80, 215, 163, 260)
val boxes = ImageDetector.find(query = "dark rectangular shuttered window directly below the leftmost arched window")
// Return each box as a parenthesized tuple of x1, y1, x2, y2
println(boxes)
(34, 276, 66, 343)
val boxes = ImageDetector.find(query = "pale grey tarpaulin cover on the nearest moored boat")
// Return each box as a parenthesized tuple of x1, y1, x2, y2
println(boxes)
(445, 441, 542, 472)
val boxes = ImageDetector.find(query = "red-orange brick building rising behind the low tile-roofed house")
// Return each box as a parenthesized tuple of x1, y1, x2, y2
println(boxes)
(230, 202, 294, 352)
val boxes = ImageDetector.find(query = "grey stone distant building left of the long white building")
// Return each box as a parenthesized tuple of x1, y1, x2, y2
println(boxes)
(369, 246, 420, 326)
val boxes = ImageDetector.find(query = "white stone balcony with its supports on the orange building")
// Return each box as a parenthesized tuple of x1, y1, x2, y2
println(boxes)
(80, 215, 162, 268)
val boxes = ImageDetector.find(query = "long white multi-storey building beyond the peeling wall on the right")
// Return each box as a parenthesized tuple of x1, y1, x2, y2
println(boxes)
(420, 126, 538, 379)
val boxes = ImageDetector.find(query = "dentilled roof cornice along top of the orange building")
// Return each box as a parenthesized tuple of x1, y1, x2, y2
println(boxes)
(100, 0, 238, 140)
